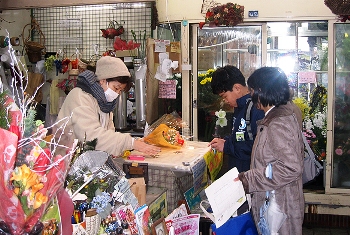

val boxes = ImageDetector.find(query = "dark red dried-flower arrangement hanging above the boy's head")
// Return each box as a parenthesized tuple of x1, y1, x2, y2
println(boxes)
(199, 2, 244, 29)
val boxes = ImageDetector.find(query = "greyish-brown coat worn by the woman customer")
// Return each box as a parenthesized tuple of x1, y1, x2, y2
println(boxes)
(240, 103, 304, 235)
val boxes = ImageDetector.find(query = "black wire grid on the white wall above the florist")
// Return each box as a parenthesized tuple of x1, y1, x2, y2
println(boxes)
(32, 2, 152, 60)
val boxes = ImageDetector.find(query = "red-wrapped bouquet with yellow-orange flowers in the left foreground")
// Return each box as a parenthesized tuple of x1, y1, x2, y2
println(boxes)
(0, 99, 73, 235)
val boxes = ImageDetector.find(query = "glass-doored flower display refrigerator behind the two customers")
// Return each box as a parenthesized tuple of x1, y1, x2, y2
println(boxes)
(191, 21, 350, 194)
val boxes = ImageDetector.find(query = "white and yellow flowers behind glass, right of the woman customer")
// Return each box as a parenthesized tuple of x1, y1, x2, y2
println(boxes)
(293, 86, 327, 160)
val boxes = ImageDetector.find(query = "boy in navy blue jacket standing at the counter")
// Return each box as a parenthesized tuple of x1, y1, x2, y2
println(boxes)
(209, 65, 264, 172)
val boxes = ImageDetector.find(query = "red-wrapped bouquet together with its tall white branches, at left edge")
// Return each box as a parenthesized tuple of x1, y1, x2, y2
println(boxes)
(0, 32, 76, 235)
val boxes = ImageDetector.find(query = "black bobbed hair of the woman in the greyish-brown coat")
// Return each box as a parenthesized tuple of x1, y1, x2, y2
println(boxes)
(247, 67, 290, 107)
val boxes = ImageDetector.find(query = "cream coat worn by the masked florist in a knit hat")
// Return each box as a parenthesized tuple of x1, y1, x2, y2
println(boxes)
(57, 88, 132, 156)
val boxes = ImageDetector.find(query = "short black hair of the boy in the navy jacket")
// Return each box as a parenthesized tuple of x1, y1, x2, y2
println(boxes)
(211, 65, 246, 94)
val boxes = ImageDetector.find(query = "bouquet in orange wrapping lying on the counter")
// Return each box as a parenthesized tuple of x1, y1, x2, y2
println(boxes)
(144, 113, 185, 149)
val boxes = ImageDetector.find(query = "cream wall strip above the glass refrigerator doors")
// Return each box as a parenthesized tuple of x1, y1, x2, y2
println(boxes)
(156, 0, 336, 23)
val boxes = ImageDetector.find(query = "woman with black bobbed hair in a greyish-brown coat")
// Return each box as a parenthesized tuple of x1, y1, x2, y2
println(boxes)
(236, 67, 304, 235)
